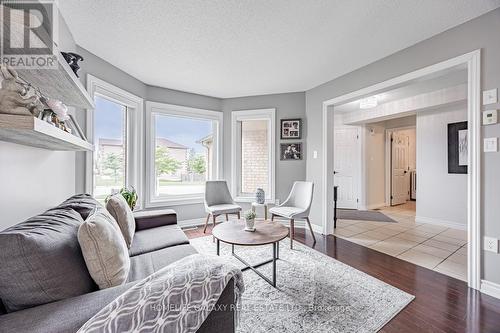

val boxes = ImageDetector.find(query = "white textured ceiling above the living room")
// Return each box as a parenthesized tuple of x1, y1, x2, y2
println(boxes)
(59, 0, 500, 98)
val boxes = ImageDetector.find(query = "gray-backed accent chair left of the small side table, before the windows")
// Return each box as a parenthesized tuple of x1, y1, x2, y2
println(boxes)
(203, 180, 241, 232)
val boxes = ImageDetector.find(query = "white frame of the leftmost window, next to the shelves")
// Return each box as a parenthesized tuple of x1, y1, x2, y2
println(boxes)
(85, 74, 144, 209)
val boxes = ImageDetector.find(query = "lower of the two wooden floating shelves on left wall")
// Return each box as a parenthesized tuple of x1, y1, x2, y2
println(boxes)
(0, 114, 94, 151)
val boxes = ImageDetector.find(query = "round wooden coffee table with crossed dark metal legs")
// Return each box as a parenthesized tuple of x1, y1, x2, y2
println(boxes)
(212, 220, 288, 287)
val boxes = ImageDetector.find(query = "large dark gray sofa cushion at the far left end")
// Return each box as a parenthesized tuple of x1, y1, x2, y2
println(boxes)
(0, 207, 96, 312)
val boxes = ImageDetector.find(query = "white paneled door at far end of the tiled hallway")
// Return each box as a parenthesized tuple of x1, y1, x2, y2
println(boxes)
(391, 132, 410, 205)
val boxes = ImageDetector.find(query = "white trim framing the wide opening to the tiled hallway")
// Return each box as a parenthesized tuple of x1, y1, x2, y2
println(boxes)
(321, 50, 481, 289)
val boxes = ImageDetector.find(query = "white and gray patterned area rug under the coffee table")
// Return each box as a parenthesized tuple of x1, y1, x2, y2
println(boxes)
(190, 236, 414, 333)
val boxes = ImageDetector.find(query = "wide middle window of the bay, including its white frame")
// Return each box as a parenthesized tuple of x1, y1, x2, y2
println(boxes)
(146, 102, 222, 206)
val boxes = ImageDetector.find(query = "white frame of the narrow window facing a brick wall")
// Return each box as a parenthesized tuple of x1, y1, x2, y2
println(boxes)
(231, 108, 276, 202)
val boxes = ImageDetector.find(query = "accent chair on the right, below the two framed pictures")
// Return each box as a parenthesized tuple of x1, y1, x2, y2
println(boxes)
(269, 182, 316, 249)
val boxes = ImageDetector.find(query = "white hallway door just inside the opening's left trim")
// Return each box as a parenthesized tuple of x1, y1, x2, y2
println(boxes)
(333, 127, 360, 209)
